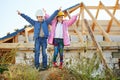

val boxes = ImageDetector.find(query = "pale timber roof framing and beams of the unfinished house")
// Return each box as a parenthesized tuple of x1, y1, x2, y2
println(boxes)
(0, 0, 120, 68)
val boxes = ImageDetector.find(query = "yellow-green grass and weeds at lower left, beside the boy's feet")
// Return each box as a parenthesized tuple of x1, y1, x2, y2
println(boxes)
(0, 49, 40, 80)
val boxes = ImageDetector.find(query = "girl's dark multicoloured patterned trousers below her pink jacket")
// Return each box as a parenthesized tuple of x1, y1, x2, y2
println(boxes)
(53, 38, 64, 62)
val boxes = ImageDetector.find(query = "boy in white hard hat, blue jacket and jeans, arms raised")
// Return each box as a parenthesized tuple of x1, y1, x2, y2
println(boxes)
(17, 9, 60, 70)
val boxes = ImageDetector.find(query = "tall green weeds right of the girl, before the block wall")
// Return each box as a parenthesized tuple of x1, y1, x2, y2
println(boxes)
(62, 53, 117, 80)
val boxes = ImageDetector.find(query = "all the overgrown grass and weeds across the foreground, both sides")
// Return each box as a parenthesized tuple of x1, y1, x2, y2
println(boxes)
(0, 45, 117, 80)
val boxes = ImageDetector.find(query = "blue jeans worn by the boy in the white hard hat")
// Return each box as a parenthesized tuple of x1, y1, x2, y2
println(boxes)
(34, 37, 47, 68)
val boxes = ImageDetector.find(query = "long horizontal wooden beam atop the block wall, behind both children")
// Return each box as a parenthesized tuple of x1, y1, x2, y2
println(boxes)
(0, 41, 120, 49)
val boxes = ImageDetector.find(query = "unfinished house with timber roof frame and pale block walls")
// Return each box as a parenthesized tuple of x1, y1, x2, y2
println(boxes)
(0, 0, 120, 73)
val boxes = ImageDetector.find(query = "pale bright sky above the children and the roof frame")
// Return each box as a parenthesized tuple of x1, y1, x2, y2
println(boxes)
(0, 0, 118, 37)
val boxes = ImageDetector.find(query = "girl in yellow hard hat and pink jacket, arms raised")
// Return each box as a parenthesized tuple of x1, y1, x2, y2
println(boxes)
(46, 11, 79, 69)
